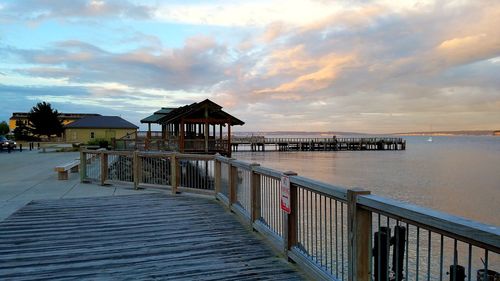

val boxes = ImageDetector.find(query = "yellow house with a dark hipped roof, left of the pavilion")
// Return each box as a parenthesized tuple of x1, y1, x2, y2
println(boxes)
(64, 116, 139, 143)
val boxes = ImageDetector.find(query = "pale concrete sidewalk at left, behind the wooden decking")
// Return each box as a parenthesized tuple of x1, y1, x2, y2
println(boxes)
(0, 150, 162, 221)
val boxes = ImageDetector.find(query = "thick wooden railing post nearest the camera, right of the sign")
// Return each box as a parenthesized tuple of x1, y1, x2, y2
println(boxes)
(347, 189, 372, 281)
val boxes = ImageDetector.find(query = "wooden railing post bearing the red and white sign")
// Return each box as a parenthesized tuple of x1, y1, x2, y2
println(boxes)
(280, 171, 298, 256)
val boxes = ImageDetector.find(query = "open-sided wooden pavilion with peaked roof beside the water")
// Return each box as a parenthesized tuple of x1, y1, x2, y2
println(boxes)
(141, 99, 245, 156)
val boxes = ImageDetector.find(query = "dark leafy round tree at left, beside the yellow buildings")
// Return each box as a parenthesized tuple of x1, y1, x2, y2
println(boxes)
(28, 102, 64, 137)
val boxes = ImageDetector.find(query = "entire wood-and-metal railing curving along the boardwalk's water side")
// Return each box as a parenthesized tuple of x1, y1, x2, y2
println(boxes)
(80, 150, 500, 281)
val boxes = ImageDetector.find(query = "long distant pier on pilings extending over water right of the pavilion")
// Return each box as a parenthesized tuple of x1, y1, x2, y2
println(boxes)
(231, 136, 406, 151)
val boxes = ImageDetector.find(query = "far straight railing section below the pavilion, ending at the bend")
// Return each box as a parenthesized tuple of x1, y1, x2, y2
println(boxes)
(80, 149, 215, 194)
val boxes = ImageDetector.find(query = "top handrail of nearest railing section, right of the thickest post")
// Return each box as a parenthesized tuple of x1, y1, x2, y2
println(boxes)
(357, 195, 500, 253)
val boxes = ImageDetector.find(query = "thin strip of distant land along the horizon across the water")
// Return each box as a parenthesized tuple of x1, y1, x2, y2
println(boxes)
(234, 130, 500, 137)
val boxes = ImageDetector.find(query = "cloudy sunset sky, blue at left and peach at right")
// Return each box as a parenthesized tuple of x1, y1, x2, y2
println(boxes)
(0, 0, 500, 133)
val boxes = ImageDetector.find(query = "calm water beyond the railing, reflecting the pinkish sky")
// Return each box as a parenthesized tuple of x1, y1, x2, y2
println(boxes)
(233, 136, 500, 225)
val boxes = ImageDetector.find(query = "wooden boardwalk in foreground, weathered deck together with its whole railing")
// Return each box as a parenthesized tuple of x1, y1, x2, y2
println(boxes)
(0, 149, 500, 281)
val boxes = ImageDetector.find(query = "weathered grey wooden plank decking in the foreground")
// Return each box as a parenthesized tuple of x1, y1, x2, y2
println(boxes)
(0, 194, 303, 280)
